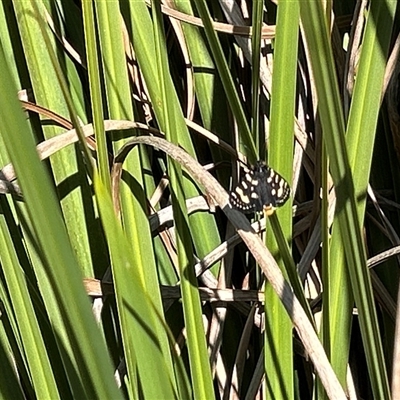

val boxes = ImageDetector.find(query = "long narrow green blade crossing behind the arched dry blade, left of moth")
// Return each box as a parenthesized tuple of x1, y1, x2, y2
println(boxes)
(152, 2, 214, 399)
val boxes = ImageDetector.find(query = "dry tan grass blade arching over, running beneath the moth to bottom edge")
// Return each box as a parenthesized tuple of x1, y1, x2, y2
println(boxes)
(112, 137, 346, 399)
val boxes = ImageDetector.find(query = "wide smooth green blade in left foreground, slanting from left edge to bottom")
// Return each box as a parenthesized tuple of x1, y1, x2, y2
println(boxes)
(0, 38, 120, 399)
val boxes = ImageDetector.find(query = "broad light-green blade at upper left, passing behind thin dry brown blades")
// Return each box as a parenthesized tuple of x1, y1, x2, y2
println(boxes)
(13, 1, 93, 276)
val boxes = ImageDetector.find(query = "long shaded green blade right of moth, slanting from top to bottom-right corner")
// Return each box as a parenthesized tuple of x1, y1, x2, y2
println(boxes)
(301, 2, 389, 398)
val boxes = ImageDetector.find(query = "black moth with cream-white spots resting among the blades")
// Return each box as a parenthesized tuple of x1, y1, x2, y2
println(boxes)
(229, 161, 290, 215)
